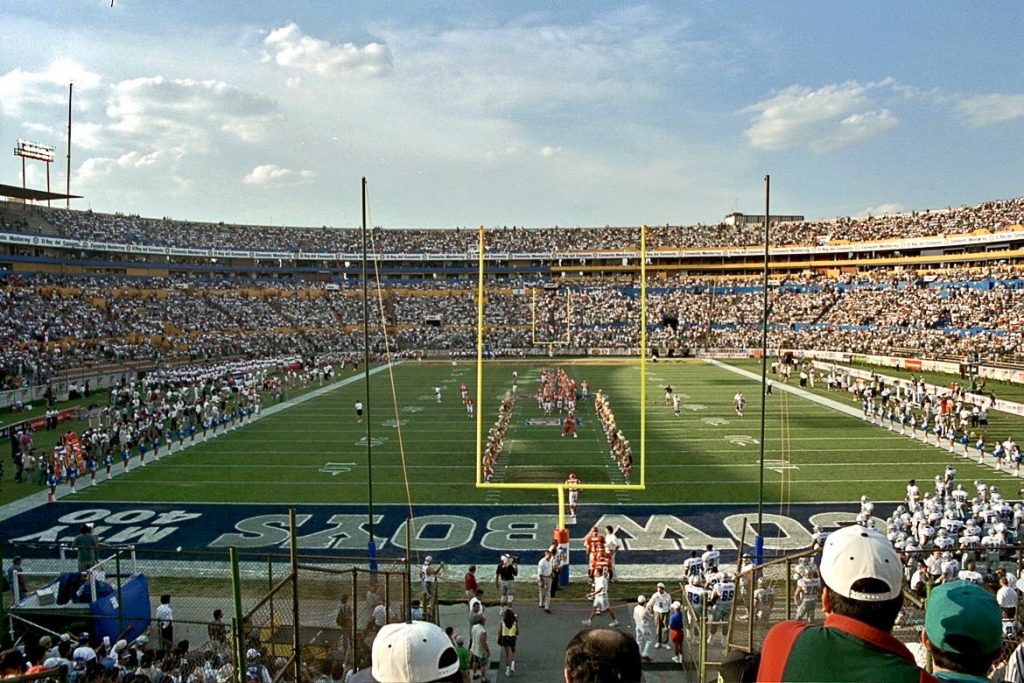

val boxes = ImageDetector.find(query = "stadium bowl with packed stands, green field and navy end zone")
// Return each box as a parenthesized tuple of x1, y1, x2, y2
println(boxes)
(6, 189, 1024, 679)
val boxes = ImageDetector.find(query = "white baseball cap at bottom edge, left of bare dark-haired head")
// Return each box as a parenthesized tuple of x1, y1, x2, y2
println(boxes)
(353, 622, 459, 683)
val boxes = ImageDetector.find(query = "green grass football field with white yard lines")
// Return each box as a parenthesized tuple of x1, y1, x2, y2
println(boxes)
(28, 360, 1024, 505)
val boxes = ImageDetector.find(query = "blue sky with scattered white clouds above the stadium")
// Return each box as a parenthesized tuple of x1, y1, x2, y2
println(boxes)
(0, 0, 1024, 227)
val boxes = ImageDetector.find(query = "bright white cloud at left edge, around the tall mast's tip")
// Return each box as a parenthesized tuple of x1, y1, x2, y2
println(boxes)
(0, 59, 101, 117)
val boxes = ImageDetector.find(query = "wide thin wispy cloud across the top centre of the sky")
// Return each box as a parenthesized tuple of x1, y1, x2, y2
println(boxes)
(379, 6, 704, 116)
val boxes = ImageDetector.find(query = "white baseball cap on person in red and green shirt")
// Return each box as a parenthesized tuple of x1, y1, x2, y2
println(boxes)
(821, 524, 903, 602)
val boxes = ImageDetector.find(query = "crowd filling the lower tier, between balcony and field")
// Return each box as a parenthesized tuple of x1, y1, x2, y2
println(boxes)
(9, 263, 1024, 389)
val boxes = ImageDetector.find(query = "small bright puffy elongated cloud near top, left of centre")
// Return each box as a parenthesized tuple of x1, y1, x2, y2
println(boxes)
(263, 23, 391, 76)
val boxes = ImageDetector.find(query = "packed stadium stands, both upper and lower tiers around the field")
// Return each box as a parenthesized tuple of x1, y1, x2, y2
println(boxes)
(0, 198, 1024, 388)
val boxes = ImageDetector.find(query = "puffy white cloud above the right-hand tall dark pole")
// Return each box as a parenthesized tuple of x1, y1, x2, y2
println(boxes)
(743, 79, 899, 153)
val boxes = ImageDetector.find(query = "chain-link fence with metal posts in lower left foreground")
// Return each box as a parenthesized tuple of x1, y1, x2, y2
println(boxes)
(0, 520, 411, 683)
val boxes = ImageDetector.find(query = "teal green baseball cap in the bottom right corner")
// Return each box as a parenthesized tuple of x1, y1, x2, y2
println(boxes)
(925, 581, 1002, 654)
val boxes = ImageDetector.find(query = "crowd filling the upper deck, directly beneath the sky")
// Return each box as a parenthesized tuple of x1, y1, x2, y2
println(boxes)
(6, 198, 1024, 254)
